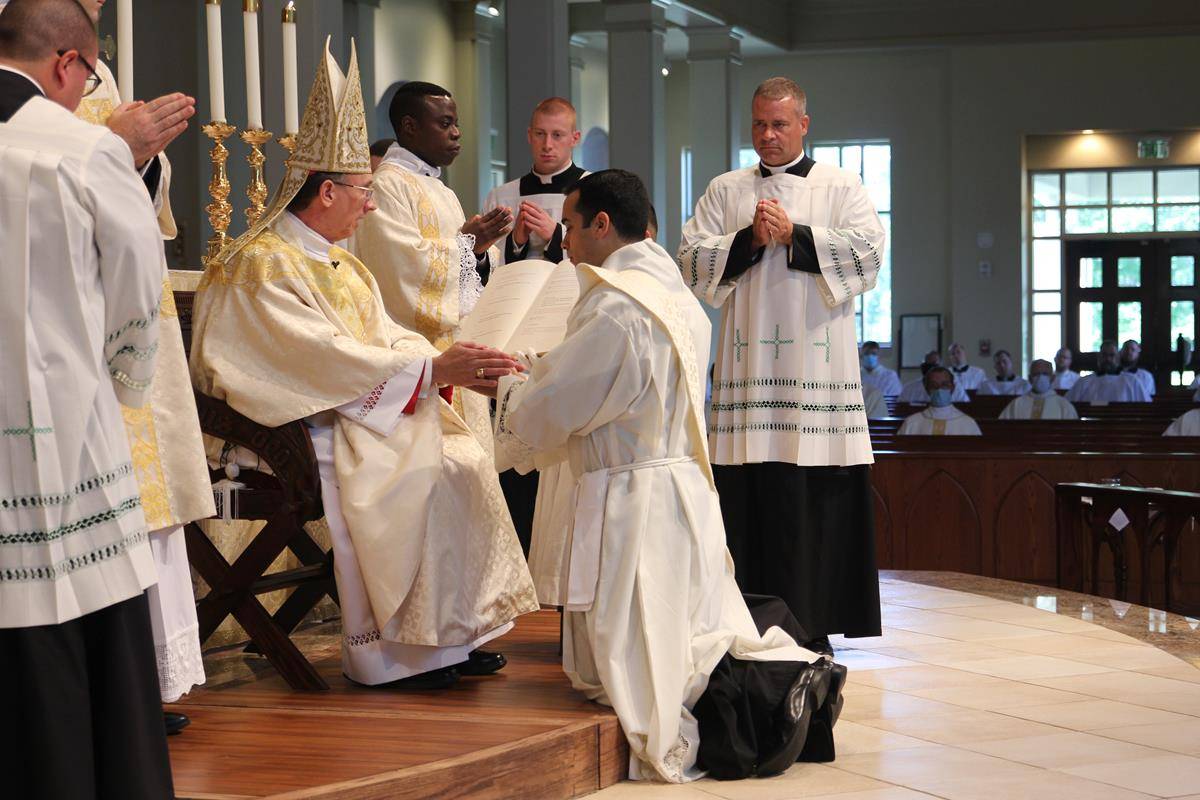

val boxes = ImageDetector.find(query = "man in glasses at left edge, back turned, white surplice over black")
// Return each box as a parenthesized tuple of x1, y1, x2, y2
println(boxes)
(0, 0, 173, 800)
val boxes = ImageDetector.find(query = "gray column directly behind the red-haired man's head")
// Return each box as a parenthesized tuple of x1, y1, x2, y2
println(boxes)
(504, 0, 571, 178)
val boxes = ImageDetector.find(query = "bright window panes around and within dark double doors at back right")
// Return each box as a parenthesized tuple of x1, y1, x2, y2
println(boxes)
(1027, 167, 1200, 359)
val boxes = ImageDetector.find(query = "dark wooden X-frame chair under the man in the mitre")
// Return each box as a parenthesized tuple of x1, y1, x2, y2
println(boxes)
(175, 291, 337, 690)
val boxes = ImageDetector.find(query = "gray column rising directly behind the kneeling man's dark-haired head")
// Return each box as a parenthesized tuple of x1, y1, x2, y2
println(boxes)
(605, 0, 666, 232)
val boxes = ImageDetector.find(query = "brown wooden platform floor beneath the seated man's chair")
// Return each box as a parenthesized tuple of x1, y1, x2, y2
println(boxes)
(169, 612, 628, 800)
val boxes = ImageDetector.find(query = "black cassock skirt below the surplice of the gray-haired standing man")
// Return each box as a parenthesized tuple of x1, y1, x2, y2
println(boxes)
(713, 462, 881, 638)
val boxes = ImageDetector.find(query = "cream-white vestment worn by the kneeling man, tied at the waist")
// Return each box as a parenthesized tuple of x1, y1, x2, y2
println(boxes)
(496, 241, 816, 782)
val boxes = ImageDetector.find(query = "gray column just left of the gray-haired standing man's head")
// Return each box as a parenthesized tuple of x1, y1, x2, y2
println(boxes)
(684, 26, 742, 211)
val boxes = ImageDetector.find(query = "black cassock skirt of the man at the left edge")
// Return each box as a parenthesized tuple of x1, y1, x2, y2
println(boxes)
(0, 594, 174, 800)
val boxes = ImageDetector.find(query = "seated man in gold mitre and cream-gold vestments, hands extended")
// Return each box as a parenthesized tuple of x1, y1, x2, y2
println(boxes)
(192, 40, 538, 688)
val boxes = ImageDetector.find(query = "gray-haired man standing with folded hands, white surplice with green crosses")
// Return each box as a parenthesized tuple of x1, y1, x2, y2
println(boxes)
(678, 78, 884, 650)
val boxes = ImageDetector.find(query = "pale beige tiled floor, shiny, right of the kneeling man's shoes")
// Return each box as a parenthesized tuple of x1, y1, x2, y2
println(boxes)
(590, 572, 1200, 800)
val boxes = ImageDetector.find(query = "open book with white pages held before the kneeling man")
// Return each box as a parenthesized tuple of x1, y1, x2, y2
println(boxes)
(458, 260, 580, 353)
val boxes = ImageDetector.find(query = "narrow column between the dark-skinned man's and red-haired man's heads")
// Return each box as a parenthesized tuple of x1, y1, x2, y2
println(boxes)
(446, 0, 492, 218)
